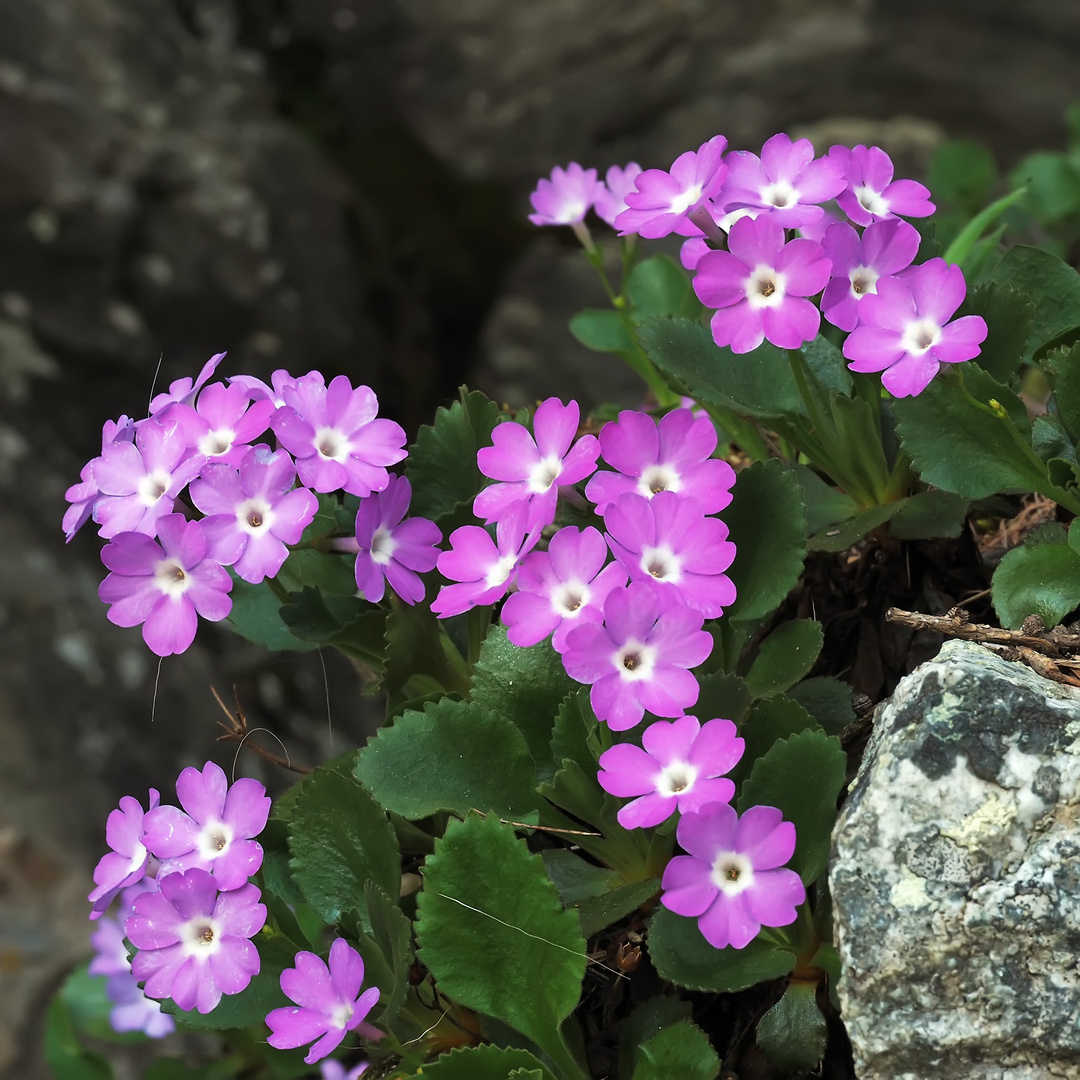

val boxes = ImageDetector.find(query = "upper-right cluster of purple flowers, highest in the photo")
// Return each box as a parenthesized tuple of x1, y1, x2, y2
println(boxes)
(531, 134, 987, 397)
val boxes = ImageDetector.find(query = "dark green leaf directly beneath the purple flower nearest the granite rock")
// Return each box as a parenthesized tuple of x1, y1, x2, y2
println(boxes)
(648, 907, 795, 994)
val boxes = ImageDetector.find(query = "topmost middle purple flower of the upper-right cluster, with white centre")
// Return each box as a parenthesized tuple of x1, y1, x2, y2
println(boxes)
(720, 134, 846, 229)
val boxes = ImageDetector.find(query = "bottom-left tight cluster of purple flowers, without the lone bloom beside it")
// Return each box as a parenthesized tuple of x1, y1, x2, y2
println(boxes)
(89, 761, 270, 1015)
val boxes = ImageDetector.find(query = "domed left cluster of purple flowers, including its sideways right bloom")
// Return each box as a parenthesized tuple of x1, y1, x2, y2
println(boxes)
(64, 353, 442, 657)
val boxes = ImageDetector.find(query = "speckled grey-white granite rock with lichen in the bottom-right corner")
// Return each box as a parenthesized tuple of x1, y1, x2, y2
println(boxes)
(829, 642, 1080, 1080)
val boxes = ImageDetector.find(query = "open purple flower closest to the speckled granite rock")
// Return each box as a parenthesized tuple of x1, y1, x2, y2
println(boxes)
(660, 802, 806, 948)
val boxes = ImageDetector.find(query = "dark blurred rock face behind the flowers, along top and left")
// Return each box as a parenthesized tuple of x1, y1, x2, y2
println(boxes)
(0, 0, 1080, 1078)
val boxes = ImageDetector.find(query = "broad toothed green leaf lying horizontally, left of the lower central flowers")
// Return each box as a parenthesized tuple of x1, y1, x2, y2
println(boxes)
(355, 698, 537, 821)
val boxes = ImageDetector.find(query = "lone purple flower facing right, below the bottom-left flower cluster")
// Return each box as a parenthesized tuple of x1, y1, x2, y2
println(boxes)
(267, 937, 382, 1065)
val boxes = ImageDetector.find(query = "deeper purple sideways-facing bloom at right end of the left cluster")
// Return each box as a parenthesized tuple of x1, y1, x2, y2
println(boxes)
(336, 476, 443, 604)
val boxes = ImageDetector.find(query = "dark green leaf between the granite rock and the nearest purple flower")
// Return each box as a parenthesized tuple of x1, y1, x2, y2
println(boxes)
(738, 731, 848, 885)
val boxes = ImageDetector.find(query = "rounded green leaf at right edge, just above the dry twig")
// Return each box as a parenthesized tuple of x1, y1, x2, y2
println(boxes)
(991, 530, 1080, 630)
